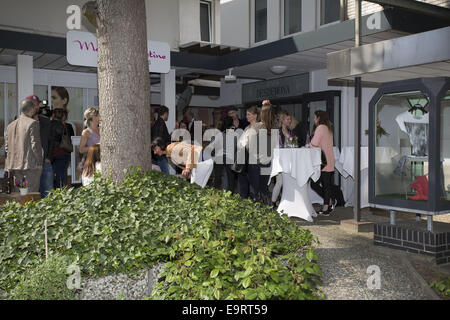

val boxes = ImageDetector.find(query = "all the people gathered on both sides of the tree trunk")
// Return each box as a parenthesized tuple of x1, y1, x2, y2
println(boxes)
(5, 92, 336, 215)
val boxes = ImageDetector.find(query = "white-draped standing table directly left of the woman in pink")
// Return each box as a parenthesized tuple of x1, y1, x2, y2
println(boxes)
(269, 148, 322, 222)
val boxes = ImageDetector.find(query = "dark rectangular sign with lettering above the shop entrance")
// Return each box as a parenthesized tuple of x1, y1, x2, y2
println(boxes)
(242, 73, 309, 103)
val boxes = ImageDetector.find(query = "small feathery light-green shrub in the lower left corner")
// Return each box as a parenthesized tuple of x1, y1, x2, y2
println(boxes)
(8, 256, 76, 300)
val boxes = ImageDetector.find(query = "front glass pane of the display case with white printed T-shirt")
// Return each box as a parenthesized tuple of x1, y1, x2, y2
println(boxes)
(373, 91, 429, 201)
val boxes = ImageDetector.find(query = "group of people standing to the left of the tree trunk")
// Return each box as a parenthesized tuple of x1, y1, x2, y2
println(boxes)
(5, 87, 100, 198)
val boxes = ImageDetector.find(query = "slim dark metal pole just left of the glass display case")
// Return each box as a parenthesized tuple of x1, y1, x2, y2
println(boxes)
(353, 0, 362, 222)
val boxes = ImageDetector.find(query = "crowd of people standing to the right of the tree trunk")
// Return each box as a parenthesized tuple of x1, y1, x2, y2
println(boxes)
(152, 100, 336, 215)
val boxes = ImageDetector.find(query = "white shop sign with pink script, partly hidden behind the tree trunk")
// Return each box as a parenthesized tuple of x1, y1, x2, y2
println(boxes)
(66, 30, 170, 73)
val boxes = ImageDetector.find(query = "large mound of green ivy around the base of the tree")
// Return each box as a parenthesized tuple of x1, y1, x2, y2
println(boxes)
(0, 168, 323, 299)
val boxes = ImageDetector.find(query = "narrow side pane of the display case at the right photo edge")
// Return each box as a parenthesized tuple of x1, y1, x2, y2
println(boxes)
(440, 90, 450, 202)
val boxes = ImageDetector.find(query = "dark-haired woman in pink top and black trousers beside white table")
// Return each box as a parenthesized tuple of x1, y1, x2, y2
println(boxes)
(311, 110, 334, 216)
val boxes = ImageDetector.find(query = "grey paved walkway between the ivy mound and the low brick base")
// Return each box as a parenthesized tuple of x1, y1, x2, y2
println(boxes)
(296, 207, 445, 300)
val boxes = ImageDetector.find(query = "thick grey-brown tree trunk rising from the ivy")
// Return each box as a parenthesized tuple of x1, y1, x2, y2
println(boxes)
(97, 0, 152, 182)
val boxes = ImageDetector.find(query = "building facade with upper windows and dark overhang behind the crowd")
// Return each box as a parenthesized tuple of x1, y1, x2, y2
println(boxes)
(0, 0, 450, 192)
